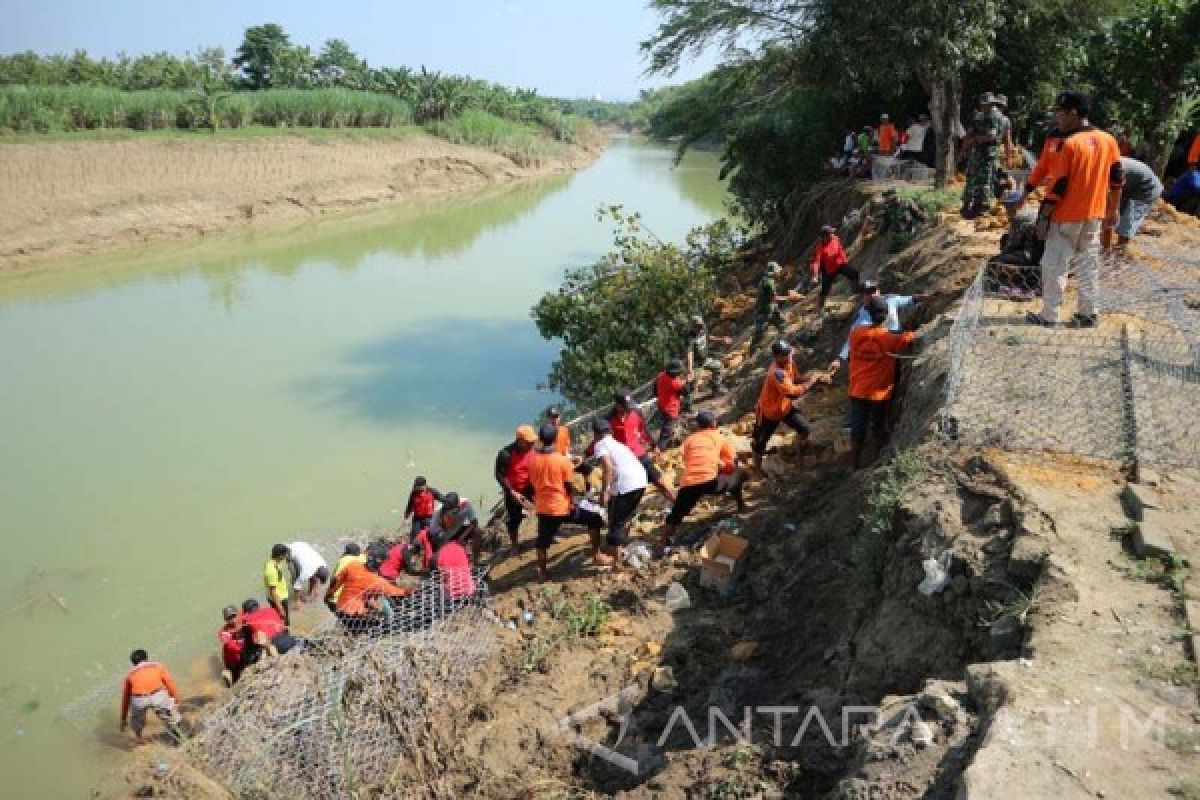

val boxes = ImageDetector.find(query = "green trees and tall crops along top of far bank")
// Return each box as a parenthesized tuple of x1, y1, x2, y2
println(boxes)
(0, 24, 600, 152)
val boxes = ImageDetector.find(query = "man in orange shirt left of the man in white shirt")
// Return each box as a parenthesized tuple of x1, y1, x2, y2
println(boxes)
(529, 425, 612, 582)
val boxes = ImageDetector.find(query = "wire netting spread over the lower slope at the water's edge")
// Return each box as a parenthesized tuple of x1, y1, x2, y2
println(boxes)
(186, 572, 497, 800)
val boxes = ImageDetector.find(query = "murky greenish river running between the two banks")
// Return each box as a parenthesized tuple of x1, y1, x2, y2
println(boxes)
(0, 139, 725, 798)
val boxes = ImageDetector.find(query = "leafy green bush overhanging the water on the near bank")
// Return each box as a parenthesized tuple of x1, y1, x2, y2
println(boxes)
(533, 205, 746, 408)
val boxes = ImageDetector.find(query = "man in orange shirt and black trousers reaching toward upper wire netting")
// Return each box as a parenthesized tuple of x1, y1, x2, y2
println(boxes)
(850, 297, 916, 469)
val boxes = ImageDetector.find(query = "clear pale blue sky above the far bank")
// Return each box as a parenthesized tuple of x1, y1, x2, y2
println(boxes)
(0, 0, 713, 100)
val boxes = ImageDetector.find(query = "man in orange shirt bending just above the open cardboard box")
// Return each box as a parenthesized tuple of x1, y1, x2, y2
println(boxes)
(659, 411, 745, 554)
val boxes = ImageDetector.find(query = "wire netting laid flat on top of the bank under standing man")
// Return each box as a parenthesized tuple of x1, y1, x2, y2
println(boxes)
(941, 240, 1200, 470)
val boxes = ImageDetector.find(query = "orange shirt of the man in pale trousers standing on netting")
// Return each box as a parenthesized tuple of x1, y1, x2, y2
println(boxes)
(1046, 128, 1123, 222)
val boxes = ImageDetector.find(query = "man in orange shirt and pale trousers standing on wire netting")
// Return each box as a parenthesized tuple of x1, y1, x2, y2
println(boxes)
(1026, 91, 1124, 327)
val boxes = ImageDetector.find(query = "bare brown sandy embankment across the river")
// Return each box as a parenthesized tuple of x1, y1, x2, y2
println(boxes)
(0, 134, 596, 270)
